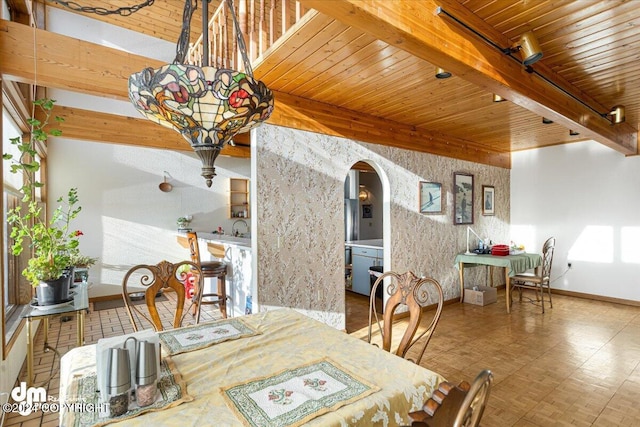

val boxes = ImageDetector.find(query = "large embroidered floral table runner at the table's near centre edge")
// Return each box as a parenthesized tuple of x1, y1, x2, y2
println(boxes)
(222, 359, 379, 427)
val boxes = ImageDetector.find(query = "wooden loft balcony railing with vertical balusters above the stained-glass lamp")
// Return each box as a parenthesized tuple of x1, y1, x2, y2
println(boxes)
(187, 0, 309, 71)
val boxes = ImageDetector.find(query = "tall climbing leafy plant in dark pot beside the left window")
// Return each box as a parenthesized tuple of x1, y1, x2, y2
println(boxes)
(3, 99, 87, 305)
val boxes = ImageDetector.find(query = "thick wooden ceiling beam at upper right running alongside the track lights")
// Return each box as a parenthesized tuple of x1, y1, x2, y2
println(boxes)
(301, 0, 638, 155)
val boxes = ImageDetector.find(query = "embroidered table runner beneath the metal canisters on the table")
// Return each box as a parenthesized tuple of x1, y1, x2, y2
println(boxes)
(63, 357, 193, 427)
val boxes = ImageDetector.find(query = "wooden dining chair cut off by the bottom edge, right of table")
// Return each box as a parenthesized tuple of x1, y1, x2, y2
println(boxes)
(409, 369, 493, 427)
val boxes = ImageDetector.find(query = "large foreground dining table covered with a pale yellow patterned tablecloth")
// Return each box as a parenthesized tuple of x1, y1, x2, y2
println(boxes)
(59, 308, 445, 427)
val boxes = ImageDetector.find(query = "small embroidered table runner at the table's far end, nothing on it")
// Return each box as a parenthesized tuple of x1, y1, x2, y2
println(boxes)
(158, 318, 260, 355)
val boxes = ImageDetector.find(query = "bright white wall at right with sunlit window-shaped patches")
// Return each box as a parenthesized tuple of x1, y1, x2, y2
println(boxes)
(511, 141, 640, 301)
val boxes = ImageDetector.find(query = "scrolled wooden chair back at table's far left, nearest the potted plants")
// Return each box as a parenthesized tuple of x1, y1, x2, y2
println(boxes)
(122, 261, 202, 331)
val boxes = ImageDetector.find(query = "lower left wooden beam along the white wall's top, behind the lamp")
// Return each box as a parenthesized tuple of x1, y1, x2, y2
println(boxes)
(36, 105, 251, 158)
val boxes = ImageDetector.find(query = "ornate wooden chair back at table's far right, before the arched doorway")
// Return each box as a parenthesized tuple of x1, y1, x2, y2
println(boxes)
(368, 271, 444, 364)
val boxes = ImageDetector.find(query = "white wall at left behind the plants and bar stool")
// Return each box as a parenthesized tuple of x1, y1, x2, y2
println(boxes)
(48, 138, 250, 296)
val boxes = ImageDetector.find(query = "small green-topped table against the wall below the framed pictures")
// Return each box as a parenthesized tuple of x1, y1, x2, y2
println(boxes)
(454, 252, 542, 314)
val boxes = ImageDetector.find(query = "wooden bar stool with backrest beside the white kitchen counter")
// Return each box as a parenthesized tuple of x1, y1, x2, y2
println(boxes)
(187, 231, 227, 323)
